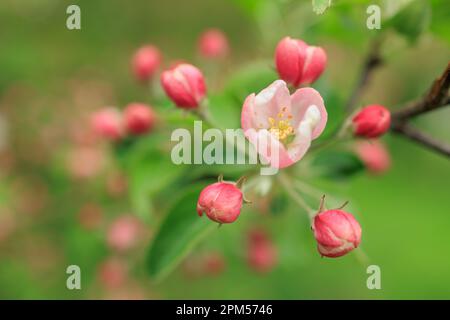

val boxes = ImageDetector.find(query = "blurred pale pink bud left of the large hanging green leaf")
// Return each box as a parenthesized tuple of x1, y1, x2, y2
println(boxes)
(107, 215, 143, 251)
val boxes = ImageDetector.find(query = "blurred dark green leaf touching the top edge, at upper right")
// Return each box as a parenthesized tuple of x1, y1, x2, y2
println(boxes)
(386, 0, 431, 43)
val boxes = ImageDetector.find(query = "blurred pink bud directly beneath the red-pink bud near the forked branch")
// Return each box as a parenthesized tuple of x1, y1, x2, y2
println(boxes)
(356, 140, 391, 174)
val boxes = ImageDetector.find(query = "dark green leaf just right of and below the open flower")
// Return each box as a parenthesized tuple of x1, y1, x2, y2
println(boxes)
(311, 151, 364, 180)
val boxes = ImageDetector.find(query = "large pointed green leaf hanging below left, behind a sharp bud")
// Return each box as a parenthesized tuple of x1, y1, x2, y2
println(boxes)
(147, 184, 218, 280)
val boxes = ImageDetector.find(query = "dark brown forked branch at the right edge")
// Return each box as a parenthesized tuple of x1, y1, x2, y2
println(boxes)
(391, 63, 450, 157)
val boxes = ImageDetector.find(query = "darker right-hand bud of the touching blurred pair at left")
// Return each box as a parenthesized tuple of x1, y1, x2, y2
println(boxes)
(124, 103, 156, 135)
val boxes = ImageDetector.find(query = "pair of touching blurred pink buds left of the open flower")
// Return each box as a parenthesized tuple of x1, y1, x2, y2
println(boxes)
(91, 102, 156, 141)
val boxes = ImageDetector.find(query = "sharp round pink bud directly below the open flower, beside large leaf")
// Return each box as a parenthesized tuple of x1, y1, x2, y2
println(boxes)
(197, 182, 243, 223)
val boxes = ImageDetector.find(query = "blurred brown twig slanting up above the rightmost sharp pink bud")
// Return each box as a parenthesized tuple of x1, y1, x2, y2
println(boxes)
(345, 39, 382, 113)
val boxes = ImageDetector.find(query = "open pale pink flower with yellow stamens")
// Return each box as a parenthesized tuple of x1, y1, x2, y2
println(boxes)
(241, 80, 327, 168)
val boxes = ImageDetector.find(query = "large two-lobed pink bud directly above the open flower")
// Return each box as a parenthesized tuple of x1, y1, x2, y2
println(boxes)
(275, 37, 327, 87)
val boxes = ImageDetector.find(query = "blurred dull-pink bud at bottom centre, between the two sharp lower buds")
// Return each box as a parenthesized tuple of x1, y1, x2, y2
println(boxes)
(247, 229, 277, 273)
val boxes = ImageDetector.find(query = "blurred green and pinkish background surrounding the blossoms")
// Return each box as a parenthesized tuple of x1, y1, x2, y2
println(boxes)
(0, 0, 450, 299)
